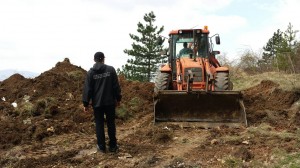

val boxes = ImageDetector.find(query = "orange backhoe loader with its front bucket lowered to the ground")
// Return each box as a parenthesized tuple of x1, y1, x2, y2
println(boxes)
(154, 26, 247, 127)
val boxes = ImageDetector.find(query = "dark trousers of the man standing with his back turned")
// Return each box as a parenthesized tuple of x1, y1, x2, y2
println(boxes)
(94, 105, 117, 150)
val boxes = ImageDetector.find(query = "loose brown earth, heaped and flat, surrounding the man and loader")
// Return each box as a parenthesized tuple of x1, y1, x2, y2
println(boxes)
(0, 59, 300, 168)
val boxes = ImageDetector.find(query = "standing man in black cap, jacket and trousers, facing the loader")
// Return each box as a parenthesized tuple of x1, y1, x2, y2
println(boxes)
(82, 52, 122, 153)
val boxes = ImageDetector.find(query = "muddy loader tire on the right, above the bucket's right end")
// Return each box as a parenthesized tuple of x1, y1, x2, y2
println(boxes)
(215, 72, 233, 91)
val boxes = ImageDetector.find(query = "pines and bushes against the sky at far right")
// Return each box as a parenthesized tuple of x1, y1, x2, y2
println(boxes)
(238, 23, 300, 73)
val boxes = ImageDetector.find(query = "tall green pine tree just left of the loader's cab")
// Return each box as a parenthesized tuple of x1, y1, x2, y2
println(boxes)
(118, 11, 166, 81)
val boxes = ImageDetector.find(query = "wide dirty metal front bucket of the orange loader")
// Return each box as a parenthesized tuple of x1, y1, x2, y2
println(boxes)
(154, 91, 247, 127)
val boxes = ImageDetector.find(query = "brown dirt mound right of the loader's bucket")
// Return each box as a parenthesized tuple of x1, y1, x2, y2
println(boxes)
(243, 80, 300, 127)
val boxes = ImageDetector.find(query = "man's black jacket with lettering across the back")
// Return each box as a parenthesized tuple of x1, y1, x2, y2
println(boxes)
(82, 62, 122, 108)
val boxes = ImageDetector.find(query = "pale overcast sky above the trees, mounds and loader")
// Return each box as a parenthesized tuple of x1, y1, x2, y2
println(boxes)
(0, 0, 300, 73)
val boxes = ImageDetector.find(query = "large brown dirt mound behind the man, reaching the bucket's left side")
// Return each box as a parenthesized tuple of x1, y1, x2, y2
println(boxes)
(0, 58, 153, 148)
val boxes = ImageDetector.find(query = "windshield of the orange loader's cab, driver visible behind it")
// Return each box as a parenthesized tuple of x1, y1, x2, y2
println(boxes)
(173, 34, 208, 58)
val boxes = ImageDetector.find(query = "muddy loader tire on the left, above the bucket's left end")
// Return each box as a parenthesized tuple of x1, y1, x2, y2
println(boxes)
(154, 71, 170, 93)
